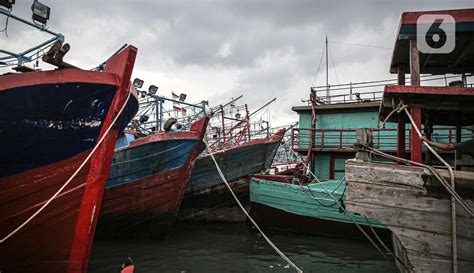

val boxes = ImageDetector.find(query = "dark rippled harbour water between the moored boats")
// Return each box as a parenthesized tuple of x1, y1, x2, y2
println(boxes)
(88, 223, 397, 273)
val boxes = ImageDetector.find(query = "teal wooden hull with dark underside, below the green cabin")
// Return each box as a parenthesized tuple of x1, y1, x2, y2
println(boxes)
(250, 175, 390, 241)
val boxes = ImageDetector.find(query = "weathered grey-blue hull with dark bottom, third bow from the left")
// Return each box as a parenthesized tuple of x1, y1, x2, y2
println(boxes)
(178, 130, 285, 222)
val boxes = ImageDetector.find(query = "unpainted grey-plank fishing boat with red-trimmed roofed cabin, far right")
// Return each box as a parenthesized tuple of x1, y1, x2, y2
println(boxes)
(345, 9, 474, 273)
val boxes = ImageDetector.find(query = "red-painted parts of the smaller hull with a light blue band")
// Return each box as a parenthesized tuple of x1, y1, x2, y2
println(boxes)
(97, 118, 208, 238)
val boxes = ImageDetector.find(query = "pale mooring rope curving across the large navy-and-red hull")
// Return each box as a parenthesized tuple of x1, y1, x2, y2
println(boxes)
(0, 92, 130, 243)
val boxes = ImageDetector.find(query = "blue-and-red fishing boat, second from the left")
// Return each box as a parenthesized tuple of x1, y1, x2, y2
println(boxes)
(97, 117, 209, 238)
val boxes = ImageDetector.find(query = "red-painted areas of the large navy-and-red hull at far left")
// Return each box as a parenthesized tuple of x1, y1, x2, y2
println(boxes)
(0, 47, 137, 273)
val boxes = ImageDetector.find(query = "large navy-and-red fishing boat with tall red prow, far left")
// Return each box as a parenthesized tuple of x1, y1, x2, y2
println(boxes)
(0, 4, 137, 273)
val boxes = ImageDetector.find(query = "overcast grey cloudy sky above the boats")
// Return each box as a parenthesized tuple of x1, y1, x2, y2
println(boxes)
(0, 0, 474, 126)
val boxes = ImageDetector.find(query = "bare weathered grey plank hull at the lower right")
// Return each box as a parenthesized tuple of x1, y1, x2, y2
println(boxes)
(346, 161, 474, 273)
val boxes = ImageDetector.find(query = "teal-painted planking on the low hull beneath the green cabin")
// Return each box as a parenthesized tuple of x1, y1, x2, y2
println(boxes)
(250, 178, 386, 228)
